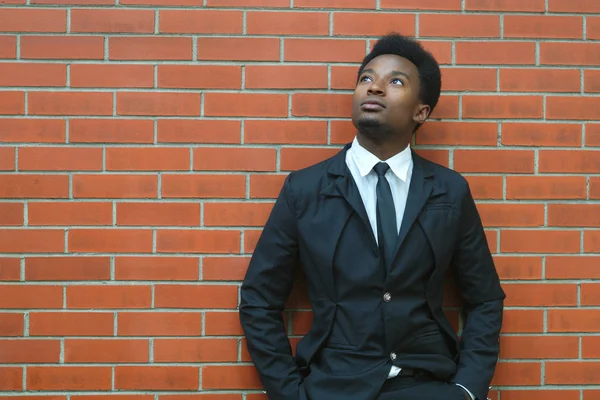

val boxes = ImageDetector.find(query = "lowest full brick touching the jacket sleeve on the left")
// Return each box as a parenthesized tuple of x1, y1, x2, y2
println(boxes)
(202, 365, 262, 389)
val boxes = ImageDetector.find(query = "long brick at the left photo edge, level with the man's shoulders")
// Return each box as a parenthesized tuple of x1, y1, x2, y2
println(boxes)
(0, 174, 69, 199)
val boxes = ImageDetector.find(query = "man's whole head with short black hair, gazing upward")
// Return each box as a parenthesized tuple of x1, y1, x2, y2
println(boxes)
(352, 33, 441, 141)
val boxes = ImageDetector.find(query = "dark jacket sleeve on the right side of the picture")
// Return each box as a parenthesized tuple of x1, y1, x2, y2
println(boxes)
(452, 182, 505, 400)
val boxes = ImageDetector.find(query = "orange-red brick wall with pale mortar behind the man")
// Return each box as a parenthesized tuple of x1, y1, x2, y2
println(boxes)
(0, 0, 600, 400)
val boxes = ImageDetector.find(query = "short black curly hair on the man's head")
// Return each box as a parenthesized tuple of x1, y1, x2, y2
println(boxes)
(357, 32, 442, 122)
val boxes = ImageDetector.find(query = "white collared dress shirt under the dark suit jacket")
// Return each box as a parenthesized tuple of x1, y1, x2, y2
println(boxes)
(346, 137, 475, 400)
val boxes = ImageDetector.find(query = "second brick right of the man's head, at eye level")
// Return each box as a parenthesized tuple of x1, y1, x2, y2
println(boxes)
(500, 68, 581, 93)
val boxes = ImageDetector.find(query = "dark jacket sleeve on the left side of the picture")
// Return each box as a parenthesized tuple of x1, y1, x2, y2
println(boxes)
(239, 174, 301, 400)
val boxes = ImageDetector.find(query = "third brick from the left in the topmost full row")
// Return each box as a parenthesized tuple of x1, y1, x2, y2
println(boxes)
(159, 10, 244, 34)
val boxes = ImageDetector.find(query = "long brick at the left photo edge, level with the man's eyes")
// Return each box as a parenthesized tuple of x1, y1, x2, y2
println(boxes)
(0, 62, 67, 87)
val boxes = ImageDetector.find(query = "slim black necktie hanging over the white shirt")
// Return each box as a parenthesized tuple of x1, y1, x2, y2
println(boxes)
(373, 162, 398, 268)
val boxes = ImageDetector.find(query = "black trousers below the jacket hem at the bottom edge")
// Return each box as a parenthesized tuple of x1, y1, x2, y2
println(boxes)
(377, 376, 465, 400)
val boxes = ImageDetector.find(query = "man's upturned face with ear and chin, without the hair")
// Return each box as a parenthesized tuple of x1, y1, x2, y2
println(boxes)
(352, 54, 429, 139)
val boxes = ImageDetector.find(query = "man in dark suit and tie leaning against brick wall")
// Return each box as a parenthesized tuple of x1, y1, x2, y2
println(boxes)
(240, 34, 505, 400)
